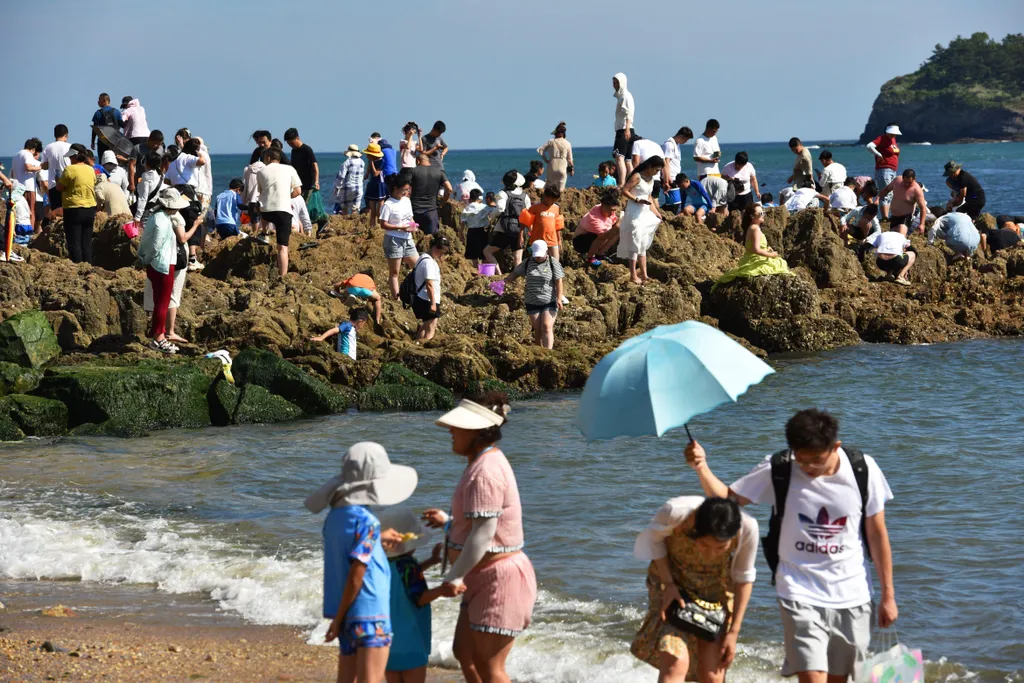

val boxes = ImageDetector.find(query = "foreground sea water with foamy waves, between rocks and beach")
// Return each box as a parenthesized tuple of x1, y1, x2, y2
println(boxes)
(0, 340, 1024, 683)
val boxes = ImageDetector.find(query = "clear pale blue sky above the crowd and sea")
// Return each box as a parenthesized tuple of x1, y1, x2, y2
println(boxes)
(8, 0, 1024, 154)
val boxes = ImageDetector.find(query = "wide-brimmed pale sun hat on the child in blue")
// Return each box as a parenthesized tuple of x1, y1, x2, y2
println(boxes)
(305, 441, 419, 512)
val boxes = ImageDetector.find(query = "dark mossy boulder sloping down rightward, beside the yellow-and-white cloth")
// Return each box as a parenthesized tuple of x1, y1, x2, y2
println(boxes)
(231, 348, 348, 415)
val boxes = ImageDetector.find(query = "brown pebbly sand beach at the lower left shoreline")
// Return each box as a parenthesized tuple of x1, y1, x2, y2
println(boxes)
(0, 597, 462, 683)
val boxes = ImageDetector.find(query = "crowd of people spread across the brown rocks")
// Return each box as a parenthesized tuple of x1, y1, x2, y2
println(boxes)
(0, 80, 1022, 353)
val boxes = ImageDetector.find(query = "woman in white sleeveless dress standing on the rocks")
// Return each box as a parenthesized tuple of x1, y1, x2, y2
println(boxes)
(617, 157, 665, 285)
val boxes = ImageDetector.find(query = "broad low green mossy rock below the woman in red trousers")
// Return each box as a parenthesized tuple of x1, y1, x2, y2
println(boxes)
(34, 360, 213, 436)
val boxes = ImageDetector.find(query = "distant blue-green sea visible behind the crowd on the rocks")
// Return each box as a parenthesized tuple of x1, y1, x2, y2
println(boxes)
(211, 142, 1024, 215)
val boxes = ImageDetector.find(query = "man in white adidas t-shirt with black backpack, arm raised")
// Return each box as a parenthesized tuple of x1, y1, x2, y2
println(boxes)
(686, 410, 899, 683)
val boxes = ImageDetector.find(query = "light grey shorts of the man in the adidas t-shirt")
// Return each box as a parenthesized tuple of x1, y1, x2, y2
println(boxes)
(778, 598, 871, 677)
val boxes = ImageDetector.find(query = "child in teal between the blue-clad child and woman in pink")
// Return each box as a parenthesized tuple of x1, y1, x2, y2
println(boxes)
(381, 507, 444, 683)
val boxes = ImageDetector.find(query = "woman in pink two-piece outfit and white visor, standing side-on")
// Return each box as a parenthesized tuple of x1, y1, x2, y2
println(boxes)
(423, 391, 537, 683)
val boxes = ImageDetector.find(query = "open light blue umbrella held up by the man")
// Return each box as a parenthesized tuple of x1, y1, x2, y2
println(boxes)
(575, 321, 775, 441)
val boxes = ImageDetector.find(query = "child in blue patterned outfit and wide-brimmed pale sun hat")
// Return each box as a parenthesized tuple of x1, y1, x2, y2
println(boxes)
(305, 441, 417, 683)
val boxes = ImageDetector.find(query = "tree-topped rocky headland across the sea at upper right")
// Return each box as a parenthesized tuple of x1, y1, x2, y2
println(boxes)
(858, 33, 1024, 144)
